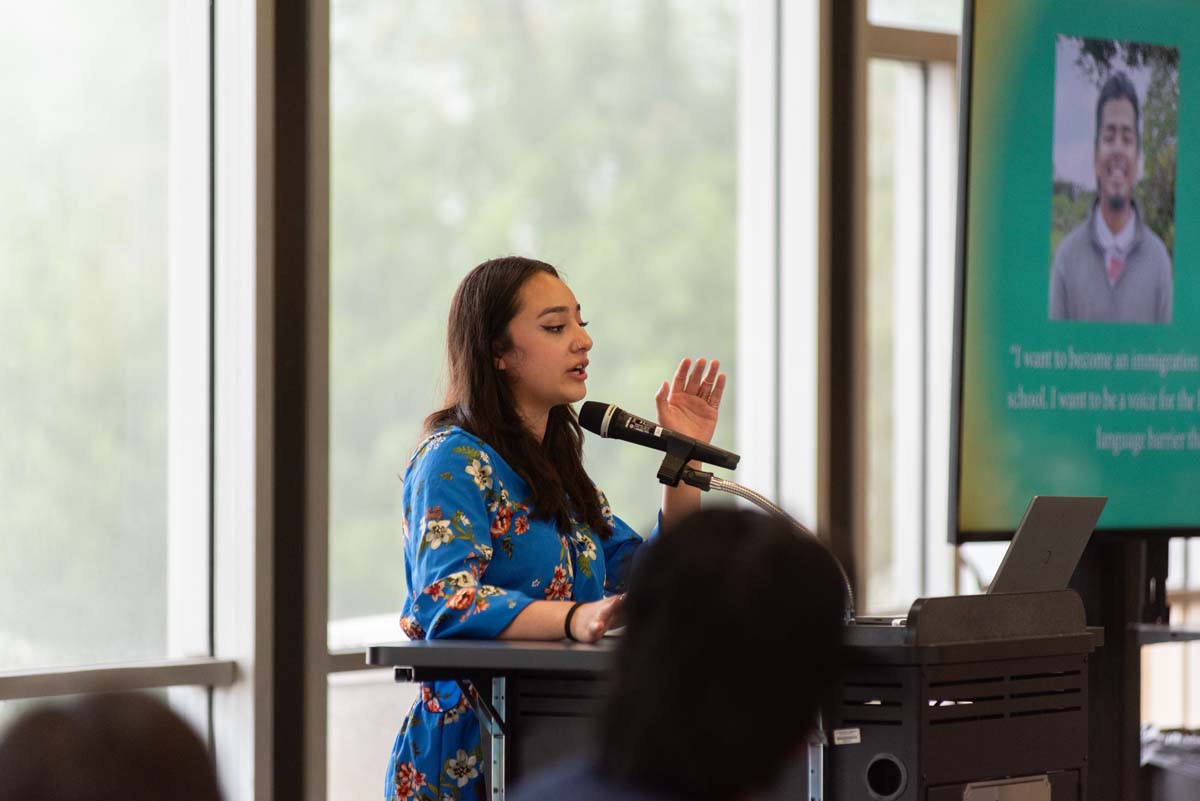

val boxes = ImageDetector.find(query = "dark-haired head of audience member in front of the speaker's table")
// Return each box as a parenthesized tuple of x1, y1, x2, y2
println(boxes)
(600, 510, 845, 801)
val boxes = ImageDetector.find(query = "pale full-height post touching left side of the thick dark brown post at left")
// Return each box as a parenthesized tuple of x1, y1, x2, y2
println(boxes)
(212, 0, 275, 801)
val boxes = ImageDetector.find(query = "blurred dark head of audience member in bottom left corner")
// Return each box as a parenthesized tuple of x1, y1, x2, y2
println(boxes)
(0, 693, 221, 801)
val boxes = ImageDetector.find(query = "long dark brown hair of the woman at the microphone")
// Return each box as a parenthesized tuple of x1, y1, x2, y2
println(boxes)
(425, 255, 612, 537)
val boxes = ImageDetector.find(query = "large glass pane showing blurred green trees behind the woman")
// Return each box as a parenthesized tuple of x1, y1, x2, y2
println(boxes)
(330, 0, 739, 637)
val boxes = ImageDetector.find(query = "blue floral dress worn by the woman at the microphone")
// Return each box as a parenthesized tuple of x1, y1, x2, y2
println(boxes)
(384, 427, 642, 801)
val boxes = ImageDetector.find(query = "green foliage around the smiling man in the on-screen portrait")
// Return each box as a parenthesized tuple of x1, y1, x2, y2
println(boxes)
(1050, 40, 1180, 265)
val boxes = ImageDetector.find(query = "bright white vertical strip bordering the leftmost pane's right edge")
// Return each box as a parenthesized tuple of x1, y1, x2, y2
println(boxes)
(167, 0, 212, 733)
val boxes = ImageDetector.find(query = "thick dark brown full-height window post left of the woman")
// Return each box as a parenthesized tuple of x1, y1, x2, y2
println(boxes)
(267, 0, 329, 799)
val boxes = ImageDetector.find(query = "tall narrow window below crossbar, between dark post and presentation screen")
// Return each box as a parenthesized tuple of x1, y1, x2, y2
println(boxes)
(860, 50, 958, 612)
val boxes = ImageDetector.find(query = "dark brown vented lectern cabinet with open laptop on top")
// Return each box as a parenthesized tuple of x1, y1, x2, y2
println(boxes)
(824, 590, 1103, 801)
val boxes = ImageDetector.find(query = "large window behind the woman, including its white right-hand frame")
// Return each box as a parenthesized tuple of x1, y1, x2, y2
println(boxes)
(328, 0, 817, 799)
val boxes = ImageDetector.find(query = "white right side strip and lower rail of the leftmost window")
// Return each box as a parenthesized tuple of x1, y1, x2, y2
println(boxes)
(0, 0, 236, 714)
